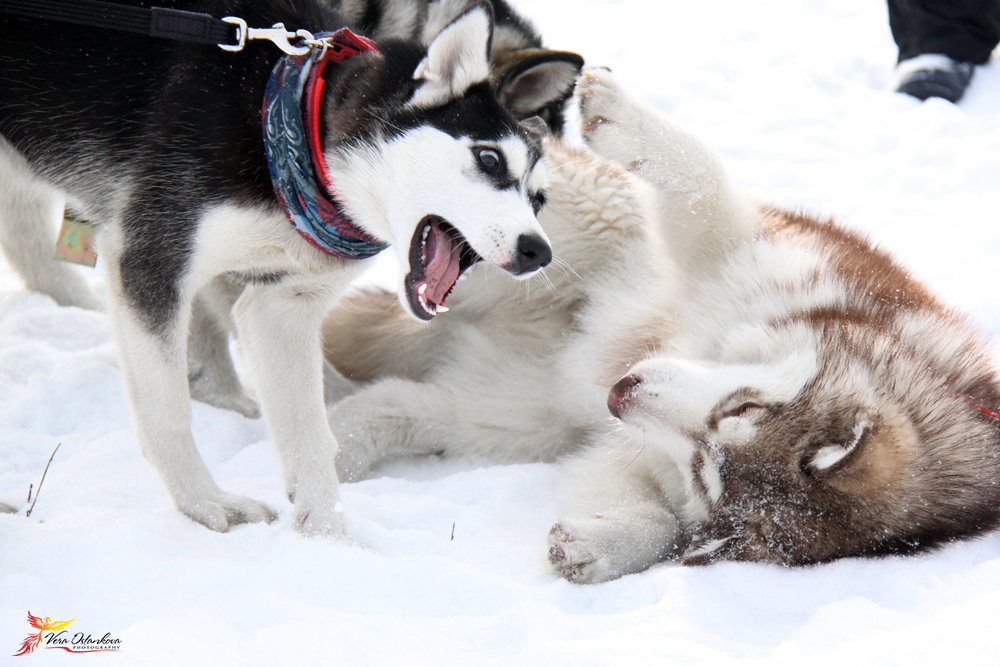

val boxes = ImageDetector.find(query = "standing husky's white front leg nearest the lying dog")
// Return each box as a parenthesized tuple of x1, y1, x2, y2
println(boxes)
(233, 283, 344, 536)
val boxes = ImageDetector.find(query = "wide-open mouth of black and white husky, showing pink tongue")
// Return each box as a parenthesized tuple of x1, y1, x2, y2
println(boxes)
(404, 215, 482, 320)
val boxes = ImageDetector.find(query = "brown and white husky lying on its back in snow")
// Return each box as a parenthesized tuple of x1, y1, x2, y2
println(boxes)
(327, 71, 1000, 582)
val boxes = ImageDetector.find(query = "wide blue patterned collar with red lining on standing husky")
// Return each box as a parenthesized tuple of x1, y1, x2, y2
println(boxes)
(261, 28, 389, 259)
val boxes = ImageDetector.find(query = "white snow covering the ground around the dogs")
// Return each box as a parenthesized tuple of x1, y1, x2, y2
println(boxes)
(0, 0, 1000, 665)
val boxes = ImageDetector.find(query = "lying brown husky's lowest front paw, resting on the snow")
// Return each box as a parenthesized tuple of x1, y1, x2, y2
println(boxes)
(548, 518, 621, 584)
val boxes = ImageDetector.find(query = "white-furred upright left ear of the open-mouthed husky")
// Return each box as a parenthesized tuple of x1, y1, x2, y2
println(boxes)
(409, 2, 493, 107)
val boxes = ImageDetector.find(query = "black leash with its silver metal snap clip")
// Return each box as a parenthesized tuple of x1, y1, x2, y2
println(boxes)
(0, 0, 328, 55)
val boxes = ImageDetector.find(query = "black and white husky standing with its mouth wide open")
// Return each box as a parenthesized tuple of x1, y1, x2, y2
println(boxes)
(0, 0, 551, 535)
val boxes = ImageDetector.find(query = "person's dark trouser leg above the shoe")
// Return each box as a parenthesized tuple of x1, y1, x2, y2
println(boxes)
(888, 0, 1000, 65)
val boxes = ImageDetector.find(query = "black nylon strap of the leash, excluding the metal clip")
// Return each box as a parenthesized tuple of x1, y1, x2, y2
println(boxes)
(0, 0, 236, 44)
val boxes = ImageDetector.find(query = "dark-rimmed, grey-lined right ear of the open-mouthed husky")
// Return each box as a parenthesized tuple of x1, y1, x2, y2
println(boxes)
(493, 49, 583, 133)
